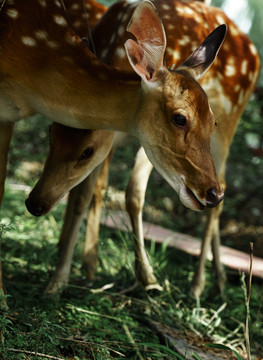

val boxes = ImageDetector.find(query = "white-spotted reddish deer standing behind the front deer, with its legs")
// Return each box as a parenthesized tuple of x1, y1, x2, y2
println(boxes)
(26, 0, 259, 297)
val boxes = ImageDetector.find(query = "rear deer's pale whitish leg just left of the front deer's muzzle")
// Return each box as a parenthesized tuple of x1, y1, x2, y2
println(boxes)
(126, 148, 157, 286)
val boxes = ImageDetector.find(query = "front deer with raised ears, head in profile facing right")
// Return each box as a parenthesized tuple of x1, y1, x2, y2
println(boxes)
(0, 0, 226, 298)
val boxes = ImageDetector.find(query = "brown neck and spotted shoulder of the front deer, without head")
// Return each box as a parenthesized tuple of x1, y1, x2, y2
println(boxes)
(0, 0, 142, 132)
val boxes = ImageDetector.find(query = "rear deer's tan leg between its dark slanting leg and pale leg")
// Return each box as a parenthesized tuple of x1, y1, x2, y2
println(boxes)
(82, 151, 113, 280)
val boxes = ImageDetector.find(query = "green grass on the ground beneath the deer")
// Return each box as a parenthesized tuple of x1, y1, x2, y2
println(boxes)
(1, 183, 263, 360)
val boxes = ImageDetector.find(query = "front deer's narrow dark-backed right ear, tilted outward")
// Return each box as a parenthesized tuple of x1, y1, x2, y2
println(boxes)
(176, 24, 227, 80)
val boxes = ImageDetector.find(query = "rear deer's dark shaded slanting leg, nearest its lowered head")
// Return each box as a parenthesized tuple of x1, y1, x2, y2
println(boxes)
(46, 165, 100, 294)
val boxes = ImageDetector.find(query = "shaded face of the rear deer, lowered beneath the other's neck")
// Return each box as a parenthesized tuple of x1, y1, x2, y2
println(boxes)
(26, 123, 114, 216)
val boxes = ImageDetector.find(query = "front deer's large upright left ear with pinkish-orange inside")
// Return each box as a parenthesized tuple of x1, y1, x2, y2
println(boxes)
(125, 0, 166, 82)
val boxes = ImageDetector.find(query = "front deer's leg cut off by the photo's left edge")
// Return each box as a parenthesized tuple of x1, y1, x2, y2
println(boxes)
(0, 122, 14, 295)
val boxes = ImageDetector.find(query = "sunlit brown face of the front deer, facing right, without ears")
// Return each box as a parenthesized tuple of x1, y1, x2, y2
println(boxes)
(137, 71, 224, 210)
